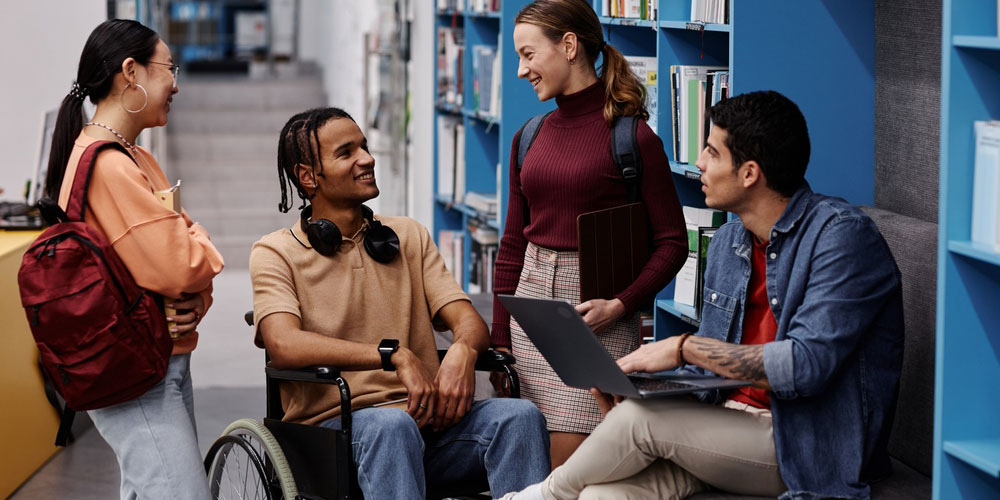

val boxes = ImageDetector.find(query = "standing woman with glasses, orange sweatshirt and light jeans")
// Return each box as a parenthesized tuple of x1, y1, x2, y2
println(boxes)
(45, 20, 222, 499)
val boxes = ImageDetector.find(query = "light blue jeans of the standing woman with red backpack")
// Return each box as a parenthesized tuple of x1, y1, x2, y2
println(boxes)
(87, 354, 211, 500)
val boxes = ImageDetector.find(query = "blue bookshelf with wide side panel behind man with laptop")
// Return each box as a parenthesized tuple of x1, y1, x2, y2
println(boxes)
(640, 0, 875, 339)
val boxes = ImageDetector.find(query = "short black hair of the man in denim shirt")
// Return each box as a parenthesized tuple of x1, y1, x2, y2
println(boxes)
(709, 90, 810, 197)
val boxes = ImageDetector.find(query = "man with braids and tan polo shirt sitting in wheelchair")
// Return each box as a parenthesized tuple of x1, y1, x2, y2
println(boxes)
(250, 108, 549, 500)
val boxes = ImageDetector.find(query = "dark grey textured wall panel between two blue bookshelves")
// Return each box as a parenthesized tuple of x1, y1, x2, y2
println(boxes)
(875, 0, 941, 222)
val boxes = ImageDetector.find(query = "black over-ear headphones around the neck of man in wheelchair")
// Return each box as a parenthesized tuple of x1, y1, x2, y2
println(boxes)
(299, 205, 399, 264)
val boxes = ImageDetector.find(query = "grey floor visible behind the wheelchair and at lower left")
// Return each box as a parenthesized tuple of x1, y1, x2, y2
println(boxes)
(10, 269, 492, 500)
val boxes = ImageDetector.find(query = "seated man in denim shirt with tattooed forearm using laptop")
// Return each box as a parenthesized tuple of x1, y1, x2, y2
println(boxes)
(500, 91, 903, 500)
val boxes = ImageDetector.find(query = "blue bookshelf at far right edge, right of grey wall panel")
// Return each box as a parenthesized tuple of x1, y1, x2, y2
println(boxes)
(934, 0, 1000, 499)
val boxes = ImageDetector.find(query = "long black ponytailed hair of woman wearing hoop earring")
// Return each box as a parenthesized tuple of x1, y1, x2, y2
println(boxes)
(45, 19, 160, 200)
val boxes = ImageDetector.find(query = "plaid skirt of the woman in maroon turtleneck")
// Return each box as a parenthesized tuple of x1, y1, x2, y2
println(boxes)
(510, 243, 639, 434)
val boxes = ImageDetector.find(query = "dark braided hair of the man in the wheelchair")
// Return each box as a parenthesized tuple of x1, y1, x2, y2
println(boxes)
(278, 108, 354, 212)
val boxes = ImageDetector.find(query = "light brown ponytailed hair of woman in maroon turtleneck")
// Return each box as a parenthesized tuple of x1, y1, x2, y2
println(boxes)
(514, 0, 649, 126)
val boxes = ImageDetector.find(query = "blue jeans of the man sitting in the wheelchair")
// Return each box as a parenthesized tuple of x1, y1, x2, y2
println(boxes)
(321, 398, 550, 500)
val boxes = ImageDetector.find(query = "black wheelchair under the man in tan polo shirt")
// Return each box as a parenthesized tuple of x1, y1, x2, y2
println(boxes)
(205, 311, 520, 500)
